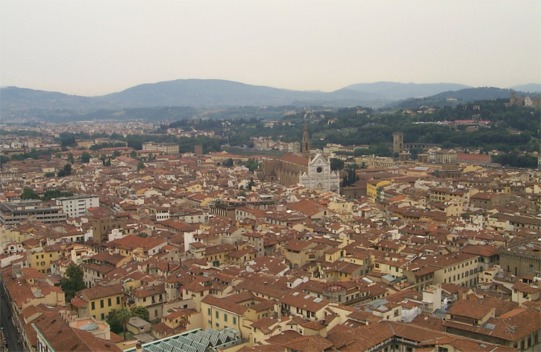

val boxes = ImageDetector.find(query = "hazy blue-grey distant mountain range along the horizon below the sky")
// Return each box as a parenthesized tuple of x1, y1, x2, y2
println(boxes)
(0, 79, 541, 120)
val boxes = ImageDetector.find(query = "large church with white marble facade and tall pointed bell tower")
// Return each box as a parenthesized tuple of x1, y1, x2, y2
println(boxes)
(262, 123, 340, 193)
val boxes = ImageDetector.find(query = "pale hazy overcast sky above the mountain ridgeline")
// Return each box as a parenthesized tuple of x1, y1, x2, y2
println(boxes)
(0, 0, 541, 95)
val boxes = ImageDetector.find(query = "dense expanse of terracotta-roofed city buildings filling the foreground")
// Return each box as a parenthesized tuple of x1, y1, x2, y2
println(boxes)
(0, 127, 541, 352)
